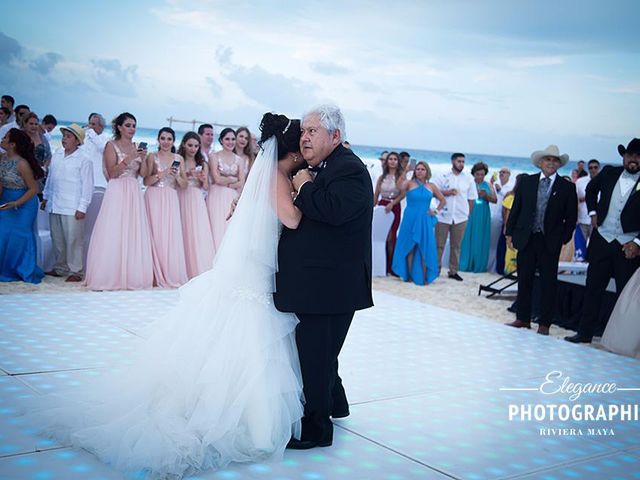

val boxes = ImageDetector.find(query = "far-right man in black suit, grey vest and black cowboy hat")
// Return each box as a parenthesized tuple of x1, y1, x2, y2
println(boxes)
(565, 138, 640, 343)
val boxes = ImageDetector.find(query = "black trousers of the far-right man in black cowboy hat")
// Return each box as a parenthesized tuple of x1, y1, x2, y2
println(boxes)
(578, 229, 640, 338)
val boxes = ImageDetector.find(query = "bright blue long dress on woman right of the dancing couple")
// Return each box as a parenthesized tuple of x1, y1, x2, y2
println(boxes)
(393, 185, 439, 285)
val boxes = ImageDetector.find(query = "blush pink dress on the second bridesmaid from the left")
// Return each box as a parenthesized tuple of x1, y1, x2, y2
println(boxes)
(144, 153, 188, 288)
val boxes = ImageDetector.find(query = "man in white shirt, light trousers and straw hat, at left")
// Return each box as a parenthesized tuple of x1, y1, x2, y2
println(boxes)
(41, 123, 93, 282)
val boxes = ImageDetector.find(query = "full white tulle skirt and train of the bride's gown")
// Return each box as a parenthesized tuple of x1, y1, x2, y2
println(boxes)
(28, 270, 303, 476)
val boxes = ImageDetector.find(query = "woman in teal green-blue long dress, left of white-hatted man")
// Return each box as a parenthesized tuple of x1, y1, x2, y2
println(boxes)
(460, 162, 497, 273)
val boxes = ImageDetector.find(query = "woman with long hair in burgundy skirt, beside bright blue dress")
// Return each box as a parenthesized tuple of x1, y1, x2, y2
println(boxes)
(373, 152, 404, 275)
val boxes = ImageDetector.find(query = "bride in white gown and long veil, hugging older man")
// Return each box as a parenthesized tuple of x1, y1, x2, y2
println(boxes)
(29, 113, 303, 477)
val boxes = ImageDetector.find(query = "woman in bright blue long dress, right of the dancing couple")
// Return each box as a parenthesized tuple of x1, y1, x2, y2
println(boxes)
(392, 161, 446, 285)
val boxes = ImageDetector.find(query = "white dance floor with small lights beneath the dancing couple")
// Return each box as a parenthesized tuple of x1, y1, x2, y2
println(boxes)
(0, 290, 640, 480)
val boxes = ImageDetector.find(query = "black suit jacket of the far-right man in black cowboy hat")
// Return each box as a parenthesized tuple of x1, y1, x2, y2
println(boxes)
(586, 165, 640, 242)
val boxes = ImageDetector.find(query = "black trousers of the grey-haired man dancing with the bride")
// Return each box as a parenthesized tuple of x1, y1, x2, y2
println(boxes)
(296, 312, 354, 443)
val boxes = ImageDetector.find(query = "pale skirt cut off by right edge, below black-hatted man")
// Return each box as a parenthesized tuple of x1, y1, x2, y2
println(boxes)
(600, 268, 640, 358)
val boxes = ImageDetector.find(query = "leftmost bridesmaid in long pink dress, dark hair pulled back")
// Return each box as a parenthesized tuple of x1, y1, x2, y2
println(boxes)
(85, 112, 153, 290)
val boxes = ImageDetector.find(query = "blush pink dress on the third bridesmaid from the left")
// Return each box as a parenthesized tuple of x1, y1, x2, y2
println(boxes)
(178, 166, 215, 279)
